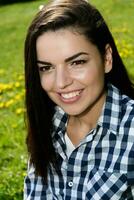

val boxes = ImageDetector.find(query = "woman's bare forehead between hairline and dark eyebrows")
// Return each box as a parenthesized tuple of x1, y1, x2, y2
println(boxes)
(36, 29, 99, 59)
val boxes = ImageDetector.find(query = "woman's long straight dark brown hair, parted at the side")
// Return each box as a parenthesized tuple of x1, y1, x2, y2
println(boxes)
(25, 0, 134, 180)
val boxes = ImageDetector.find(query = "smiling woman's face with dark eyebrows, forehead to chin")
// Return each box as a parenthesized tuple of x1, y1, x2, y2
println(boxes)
(36, 29, 111, 115)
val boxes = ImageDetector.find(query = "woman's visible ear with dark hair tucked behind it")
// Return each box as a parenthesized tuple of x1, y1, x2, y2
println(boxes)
(104, 44, 113, 73)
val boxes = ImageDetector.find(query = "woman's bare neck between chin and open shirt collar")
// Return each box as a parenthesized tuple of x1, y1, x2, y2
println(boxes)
(67, 92, 106, 145)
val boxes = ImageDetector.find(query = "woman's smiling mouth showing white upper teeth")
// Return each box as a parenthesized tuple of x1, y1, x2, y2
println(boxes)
(60, 90, 82, 103)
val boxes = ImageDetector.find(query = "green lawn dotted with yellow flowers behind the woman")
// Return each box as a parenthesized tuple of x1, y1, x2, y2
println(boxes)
(0, 0, 134, 200)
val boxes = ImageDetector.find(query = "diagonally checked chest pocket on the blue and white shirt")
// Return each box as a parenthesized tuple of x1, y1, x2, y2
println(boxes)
(86, 168, 127, 200)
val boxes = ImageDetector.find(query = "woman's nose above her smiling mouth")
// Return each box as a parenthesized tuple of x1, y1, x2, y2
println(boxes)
(56, 65, 73, 89)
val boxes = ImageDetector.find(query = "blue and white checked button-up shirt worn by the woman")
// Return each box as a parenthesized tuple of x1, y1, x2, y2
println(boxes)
(24, 85, 134, 200)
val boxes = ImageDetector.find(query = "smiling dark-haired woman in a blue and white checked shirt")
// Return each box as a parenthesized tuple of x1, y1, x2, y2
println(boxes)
(24, 0, 134, 200)
